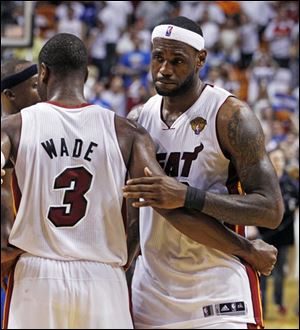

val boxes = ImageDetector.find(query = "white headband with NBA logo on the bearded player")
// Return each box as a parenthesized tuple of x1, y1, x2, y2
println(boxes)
(151, 24, 204, 50)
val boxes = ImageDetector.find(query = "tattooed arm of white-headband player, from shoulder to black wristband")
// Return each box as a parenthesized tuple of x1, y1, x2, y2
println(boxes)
(202, 98, 283, 228)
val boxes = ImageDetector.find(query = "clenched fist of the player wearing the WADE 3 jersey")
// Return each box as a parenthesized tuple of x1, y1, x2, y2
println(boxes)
(246, 239, 278, 276)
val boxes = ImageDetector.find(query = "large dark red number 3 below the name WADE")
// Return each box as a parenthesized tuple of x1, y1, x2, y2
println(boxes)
(47, 166, 93, 227)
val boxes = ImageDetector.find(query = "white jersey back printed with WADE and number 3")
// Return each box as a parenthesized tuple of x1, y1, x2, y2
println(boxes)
(9, 102, 127, 265)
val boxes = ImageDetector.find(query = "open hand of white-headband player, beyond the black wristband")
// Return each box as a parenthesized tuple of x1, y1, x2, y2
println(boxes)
(123, 167, 187, 209)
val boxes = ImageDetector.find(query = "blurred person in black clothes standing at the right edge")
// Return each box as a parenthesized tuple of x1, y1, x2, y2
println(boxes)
(258, 148, 299, 314)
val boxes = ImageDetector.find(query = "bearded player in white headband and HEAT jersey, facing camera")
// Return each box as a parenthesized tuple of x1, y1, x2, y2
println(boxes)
(124, 17, 283, 329)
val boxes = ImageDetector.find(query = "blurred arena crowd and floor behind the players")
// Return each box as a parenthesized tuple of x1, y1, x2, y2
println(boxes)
(1, 1, 299, 329)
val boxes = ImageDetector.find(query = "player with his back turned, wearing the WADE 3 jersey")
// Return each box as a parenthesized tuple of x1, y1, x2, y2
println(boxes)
(1, 34, 276, 329)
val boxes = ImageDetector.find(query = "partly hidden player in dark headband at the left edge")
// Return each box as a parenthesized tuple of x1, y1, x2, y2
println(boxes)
(1, 59, 40, 287)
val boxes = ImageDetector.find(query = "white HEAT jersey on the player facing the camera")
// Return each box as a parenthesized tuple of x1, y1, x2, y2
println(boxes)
(133, 85, 259, 329)
